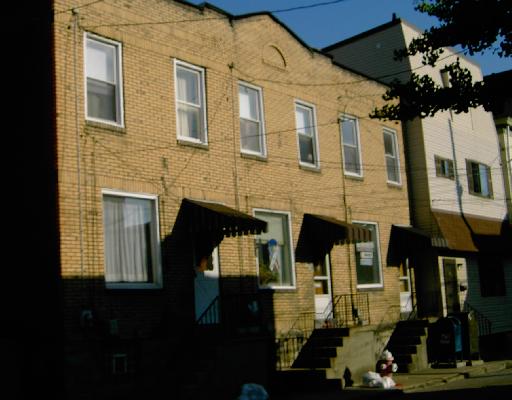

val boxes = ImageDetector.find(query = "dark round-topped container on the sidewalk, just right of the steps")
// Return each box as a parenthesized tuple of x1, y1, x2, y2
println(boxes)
(430, 316, 462, 365)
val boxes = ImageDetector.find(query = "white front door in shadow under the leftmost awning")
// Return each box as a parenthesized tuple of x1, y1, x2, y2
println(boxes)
(194, 247, 219, 322)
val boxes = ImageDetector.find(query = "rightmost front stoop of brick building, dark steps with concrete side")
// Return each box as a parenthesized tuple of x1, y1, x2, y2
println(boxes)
(386, 319, 429, 373)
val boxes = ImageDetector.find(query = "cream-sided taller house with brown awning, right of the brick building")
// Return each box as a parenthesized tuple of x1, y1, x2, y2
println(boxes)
(324, 18, 512, 358)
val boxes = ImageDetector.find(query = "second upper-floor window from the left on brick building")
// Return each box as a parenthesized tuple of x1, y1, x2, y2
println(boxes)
(174, 61, 207, 144)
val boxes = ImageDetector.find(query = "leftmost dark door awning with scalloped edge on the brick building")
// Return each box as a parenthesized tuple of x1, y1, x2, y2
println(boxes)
(180, 198, 267, 237)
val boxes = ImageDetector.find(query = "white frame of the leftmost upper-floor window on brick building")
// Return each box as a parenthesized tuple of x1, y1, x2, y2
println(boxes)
(83, 32, 124, 128)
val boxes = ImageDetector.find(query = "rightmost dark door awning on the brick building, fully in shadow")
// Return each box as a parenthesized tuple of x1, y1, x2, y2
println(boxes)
(387, 225, 431, 265)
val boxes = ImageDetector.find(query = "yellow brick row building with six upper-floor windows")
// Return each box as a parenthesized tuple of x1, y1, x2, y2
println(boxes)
(47, 0, 410, 398)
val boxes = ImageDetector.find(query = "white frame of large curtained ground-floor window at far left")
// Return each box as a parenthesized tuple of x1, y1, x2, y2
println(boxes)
(101, 189, 162, 289)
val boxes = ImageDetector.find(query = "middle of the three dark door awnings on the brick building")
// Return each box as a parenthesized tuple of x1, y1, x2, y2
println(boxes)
(295, 214, 372, 263)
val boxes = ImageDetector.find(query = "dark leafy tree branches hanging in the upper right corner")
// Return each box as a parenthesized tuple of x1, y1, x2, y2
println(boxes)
(371, 0, 512, 120)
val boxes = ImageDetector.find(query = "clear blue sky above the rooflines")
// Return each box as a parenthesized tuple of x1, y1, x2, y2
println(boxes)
(188, 0, 512, 75)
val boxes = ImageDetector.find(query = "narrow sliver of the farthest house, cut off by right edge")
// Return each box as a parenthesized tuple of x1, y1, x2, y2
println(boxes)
(484, 70, 512, 223)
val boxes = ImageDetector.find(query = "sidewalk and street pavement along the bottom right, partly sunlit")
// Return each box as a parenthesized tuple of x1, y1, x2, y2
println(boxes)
(270, 360, 512, 400)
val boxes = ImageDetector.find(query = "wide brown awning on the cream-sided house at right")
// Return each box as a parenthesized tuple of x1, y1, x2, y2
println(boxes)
(432, 211, 512, 252)
